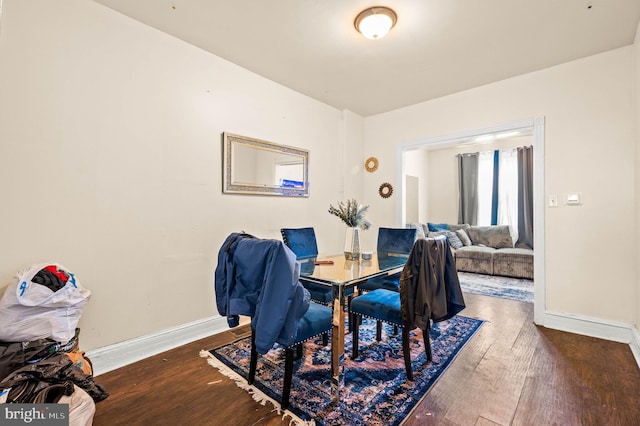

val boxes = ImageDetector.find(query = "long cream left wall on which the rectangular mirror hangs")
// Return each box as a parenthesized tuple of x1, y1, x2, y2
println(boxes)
(0, 0, 362, 350)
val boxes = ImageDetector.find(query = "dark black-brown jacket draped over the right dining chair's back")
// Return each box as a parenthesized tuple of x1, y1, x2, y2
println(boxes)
(400, 236, 465, 330)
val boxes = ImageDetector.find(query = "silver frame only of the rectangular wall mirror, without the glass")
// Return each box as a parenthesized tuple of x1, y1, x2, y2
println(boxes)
(222, 132, 309, 197)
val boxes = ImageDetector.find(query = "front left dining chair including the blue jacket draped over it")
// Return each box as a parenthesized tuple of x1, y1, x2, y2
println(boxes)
(214, 233, 333, 408)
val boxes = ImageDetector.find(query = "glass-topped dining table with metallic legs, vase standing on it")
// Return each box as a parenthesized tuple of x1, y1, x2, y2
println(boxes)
(298, 252, 408, 402)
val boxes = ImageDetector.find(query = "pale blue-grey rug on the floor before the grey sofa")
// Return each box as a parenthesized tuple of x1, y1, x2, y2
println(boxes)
(458, 272, 533, 303)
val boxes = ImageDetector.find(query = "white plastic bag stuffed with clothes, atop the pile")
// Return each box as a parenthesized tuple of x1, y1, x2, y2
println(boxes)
(0, 263, 91, 343)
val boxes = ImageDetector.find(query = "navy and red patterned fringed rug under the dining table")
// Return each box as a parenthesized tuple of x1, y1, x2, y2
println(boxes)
(201, 315, 483, 426)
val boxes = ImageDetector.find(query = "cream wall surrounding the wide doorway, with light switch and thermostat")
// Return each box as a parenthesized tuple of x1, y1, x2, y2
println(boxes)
(365, 46, 637, 324)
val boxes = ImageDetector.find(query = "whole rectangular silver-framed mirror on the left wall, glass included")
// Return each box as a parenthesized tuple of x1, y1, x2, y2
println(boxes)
(222, 132, 309, 197)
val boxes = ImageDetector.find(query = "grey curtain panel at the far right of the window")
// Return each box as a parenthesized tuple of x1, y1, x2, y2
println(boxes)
(516, 146, 533, 249)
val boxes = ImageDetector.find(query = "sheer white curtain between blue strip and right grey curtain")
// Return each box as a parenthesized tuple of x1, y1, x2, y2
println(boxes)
(498, 148, 518, 242)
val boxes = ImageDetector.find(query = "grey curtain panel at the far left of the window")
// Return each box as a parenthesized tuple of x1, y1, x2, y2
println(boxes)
(458, 153, 478, 225)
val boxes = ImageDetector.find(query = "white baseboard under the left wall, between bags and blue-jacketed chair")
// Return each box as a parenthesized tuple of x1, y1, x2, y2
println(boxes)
(87, 315, 229, 376)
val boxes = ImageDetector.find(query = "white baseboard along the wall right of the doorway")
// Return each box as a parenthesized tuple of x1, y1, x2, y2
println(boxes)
(540, 311, 640, 367)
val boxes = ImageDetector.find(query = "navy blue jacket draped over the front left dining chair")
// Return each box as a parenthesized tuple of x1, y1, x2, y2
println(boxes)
(215, 233, 310, 354)
